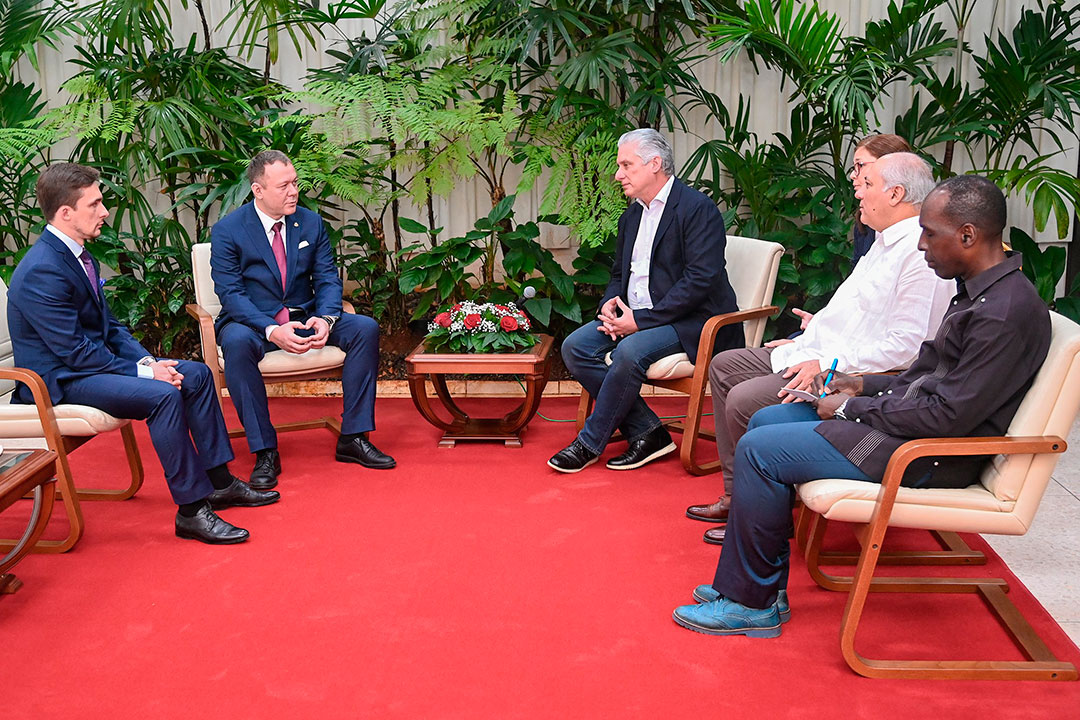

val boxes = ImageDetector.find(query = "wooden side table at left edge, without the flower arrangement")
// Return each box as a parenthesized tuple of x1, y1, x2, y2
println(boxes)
(0, 450, 56, 595)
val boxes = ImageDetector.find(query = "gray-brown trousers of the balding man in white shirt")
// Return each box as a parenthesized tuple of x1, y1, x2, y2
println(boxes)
(708, 348, 791, 497)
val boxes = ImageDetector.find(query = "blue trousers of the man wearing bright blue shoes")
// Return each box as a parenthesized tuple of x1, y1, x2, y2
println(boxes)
(713, 403, 881, 608)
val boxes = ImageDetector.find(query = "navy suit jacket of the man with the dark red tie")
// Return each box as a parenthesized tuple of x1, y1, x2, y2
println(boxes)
(210, 203, 342, 336)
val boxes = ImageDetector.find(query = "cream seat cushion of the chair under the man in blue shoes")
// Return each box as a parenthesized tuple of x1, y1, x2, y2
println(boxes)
(798, 479, 1027, 534)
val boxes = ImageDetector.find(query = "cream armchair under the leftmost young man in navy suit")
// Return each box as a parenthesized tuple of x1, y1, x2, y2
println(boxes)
(0, 282, 143, 553)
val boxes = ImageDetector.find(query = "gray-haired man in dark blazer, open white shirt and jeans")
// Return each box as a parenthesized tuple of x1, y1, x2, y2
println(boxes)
(548, 128, 743, 473)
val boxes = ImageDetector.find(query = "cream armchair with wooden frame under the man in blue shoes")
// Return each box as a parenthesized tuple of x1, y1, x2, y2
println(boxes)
(798, 313, 1080, 680)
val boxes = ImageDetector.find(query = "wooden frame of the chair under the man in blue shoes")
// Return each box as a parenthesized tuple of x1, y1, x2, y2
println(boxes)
(800, 436, 1078, 680)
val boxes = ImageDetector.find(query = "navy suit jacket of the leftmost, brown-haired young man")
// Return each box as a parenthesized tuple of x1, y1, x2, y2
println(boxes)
(8, 230, 150, 403)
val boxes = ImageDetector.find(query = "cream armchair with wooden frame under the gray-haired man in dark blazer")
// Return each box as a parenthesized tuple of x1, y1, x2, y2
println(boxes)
(578, 235, 784, 475)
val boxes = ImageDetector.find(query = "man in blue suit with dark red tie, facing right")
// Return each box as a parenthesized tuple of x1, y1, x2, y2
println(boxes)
(211, 150, 396, 490)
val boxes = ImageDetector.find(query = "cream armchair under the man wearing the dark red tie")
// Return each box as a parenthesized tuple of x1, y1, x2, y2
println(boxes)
(187, 243, 353, 437)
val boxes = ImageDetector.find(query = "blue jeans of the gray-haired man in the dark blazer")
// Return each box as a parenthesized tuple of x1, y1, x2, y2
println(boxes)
(563, 321, 683, 454)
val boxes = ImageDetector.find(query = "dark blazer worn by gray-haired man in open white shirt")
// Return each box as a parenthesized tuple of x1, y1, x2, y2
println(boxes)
(602, 178, 745, 362)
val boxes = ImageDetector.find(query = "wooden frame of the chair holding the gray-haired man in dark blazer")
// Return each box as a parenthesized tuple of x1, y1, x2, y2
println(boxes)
(577, 305, 780, 475)
